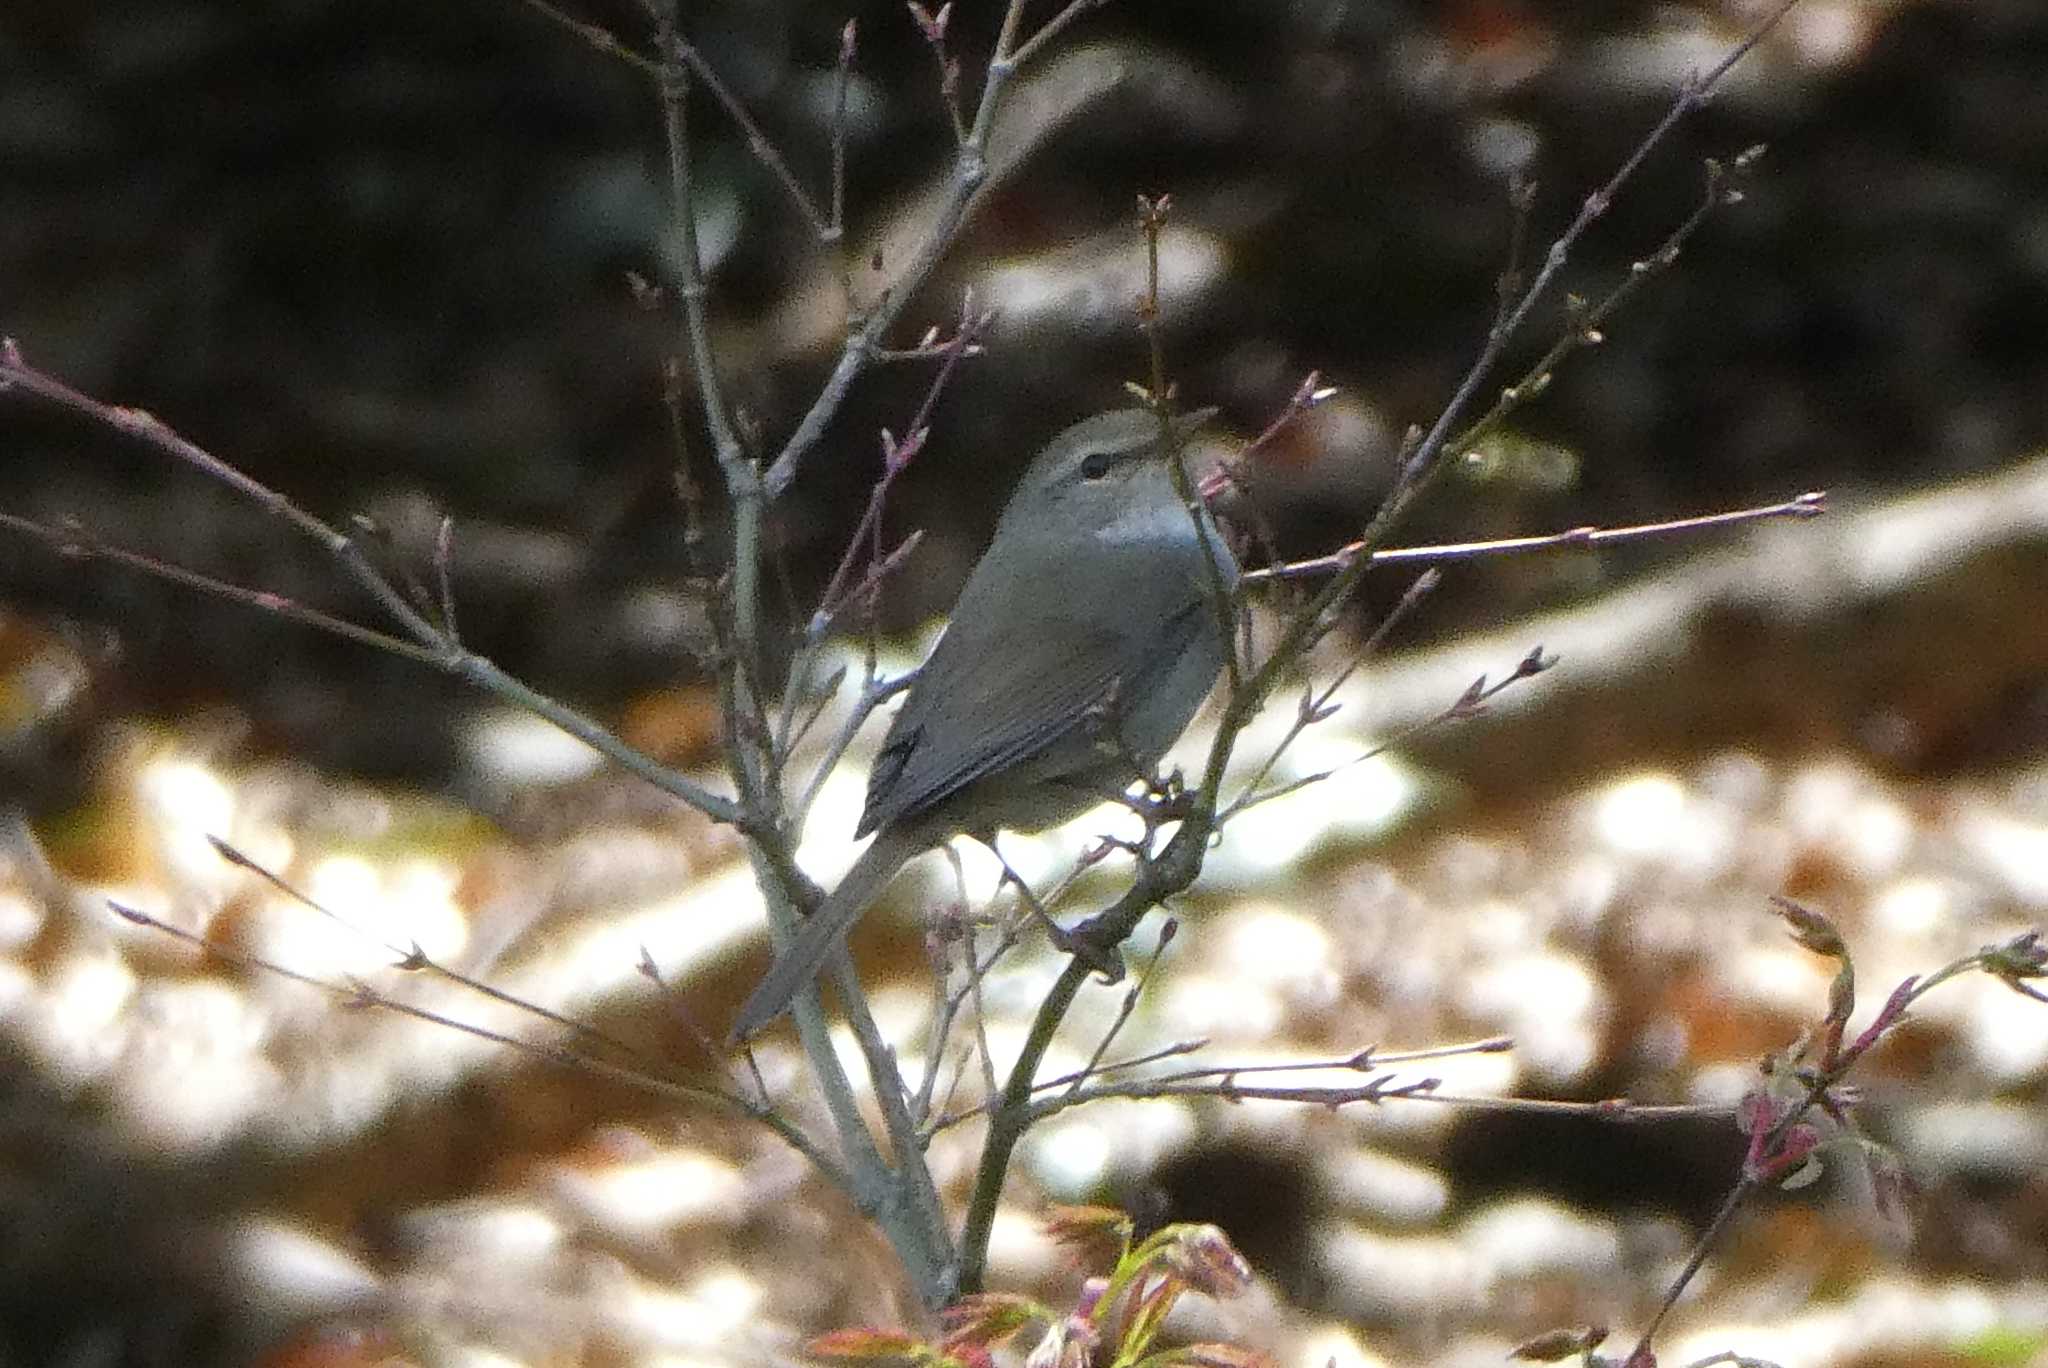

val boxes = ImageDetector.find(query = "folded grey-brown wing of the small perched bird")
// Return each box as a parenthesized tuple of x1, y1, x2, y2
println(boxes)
(860, 604, 1157, 833)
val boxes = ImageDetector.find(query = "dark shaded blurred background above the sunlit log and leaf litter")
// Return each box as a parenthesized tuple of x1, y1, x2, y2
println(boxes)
(0, 0, 2048, 786)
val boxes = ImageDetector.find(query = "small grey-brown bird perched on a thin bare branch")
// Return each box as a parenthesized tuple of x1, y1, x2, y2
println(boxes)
(733, 410, 1237, 1038)
